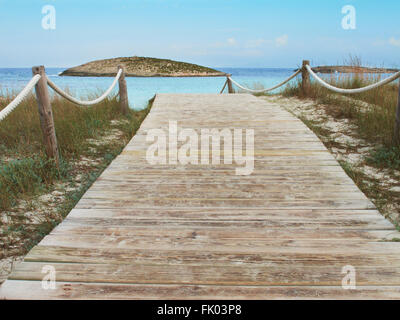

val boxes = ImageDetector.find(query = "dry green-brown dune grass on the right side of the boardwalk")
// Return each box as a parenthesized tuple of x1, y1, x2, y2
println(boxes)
(282, 73, 400, 169)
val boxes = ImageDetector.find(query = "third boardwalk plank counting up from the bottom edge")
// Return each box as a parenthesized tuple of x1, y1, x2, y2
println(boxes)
(25, 245, 400, 268)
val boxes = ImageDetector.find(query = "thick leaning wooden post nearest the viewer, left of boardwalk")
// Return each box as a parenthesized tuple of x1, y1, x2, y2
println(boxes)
(32, 66, 60, 167)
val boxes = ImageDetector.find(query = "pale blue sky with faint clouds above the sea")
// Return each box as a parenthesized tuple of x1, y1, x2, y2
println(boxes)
(0, 0, 400, 67)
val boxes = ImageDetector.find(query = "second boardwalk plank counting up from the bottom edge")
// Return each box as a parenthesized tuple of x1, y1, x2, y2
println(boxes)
(9, 261, 400, 286)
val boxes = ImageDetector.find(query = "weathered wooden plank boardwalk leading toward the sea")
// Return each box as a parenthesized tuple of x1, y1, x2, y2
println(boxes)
(0, 94, 400, 299)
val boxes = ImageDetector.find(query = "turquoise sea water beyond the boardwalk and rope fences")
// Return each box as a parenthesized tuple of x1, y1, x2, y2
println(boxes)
(0, 68, 294, 109)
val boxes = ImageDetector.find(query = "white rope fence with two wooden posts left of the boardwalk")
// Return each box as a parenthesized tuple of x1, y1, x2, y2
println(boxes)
(0, 66, 129, 166)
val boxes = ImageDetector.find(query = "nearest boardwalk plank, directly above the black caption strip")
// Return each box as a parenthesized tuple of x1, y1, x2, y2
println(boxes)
(0, 280, 400, 300)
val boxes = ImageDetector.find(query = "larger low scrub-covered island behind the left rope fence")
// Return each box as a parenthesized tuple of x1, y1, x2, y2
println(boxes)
(60, 57, 226, 77)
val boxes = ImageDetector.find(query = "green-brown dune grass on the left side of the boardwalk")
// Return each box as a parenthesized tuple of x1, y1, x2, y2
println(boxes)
(0, 95, 149, 212)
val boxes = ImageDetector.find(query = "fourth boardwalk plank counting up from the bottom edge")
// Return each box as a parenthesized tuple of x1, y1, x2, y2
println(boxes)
(36, 234, 400, 254)
